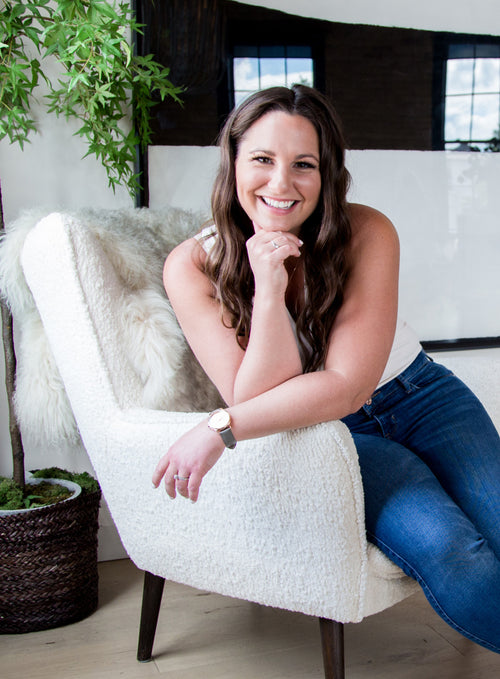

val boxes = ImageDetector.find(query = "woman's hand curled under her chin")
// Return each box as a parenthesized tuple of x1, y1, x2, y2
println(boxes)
(247, 224, 302, 296)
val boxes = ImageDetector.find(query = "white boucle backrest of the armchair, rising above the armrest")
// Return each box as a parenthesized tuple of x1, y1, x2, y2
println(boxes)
(22, 214, 142, 446)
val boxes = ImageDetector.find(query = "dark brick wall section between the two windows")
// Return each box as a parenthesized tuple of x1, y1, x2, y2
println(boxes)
(325, 24, 434, 150)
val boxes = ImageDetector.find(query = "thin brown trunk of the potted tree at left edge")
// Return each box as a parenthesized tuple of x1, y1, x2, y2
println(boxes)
(0, 185, 25, 488)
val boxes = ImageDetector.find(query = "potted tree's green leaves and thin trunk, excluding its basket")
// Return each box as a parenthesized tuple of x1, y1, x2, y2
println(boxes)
(0, 0, 181, 486)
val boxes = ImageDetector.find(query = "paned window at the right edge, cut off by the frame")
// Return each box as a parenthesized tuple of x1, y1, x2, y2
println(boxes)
(444, 43, 500, 151)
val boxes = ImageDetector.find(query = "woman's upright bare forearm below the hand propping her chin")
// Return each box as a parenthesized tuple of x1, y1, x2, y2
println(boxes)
(233, 295, 302, 403)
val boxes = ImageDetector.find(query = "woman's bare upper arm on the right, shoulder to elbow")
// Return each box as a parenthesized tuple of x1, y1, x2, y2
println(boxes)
(325, 205, 399, 410)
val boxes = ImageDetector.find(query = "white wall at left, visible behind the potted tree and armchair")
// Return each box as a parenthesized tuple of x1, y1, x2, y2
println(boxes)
(0, 37, 133, 559)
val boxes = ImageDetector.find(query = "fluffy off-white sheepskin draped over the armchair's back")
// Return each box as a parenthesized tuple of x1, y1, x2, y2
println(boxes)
(0, 208, 225, 443)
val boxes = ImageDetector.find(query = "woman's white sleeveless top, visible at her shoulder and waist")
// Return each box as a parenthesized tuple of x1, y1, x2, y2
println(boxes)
(195, 226, 422, 389)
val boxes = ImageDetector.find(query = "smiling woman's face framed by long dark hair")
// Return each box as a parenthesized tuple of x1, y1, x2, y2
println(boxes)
(235, 111, 321, 234)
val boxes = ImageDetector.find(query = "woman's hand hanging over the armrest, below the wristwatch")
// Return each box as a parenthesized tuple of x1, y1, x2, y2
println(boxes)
(153, 420, 224, 502)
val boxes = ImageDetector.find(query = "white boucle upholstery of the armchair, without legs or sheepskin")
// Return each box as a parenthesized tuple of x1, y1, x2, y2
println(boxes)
(17, 214, 416, 622)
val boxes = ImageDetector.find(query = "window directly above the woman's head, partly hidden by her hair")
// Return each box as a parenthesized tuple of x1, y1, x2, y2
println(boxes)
(230, 45, 315, 106)
